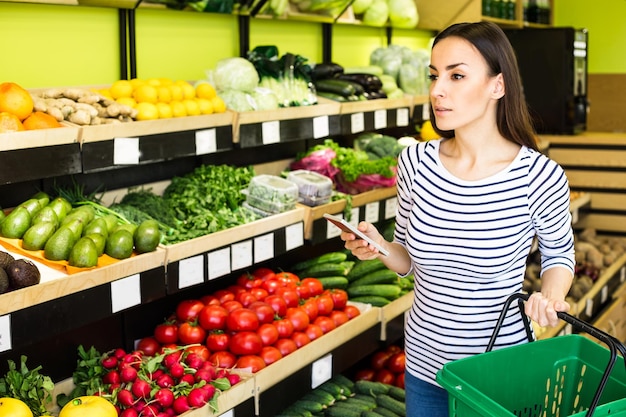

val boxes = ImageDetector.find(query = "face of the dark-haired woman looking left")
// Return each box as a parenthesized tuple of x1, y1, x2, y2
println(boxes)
(430, 36, 504, 131)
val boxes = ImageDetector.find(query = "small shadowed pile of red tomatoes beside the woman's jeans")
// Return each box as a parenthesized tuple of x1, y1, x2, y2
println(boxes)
(354, 345, 406, 388)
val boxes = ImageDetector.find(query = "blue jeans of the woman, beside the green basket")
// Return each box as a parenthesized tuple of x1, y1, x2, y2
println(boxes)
(404, 372, 449, 417)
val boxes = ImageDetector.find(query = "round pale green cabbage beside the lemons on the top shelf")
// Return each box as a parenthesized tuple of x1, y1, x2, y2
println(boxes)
(213, 57, 259, 92)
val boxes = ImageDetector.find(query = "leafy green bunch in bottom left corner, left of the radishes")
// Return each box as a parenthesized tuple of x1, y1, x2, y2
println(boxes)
(0, 355, 54, 417)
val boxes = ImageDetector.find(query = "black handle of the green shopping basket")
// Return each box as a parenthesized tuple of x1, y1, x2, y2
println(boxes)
(486, 293, 626, 417)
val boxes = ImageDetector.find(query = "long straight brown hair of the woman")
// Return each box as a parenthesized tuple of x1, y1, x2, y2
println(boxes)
(431, 22, 538, 150)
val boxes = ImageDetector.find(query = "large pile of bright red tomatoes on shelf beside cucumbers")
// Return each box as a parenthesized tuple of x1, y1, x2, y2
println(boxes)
(138, 268, 360, 372)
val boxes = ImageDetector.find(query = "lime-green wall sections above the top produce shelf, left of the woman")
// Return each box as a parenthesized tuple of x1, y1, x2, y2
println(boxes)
(0, 2, 432, 88)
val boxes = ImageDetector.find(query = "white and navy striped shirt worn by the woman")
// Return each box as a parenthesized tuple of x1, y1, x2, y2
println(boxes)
(394, 140, 574, 384)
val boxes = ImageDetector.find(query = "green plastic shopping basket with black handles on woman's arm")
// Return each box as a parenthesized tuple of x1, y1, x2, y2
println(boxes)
(437, 294, 626, 417)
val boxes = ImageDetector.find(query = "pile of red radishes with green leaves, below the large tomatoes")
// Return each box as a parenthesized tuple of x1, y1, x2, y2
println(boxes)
(100, 345, 241, 417)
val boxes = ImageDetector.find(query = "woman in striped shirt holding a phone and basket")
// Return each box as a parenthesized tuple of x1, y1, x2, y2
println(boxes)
(341, 22, 574, 417)
